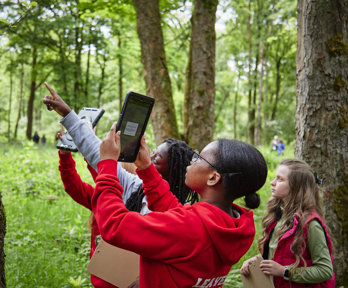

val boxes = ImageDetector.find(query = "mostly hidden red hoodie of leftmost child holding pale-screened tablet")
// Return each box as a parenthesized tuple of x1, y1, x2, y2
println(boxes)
(59, 152, 117, 288)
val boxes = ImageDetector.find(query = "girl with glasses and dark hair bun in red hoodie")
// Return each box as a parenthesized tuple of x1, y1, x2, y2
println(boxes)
(92, 124, 267, 288)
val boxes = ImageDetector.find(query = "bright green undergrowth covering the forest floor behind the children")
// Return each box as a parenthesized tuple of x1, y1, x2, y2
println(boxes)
(0, 142, 293, 288)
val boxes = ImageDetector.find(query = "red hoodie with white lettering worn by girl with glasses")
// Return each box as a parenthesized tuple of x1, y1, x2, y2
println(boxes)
(92, 159, 255, 288)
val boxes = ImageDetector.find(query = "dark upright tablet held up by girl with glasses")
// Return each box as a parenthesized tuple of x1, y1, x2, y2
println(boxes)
(116, 92, 155, 162)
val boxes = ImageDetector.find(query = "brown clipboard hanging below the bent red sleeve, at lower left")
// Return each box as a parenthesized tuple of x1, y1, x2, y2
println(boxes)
(87, 239, 140, 288)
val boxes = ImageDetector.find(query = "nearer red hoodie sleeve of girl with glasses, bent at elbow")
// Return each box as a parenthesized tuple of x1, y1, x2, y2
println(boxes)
(92, 159, 198, 261)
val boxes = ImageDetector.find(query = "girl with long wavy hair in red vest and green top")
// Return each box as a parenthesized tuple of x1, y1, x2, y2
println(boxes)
(241, 159, 335, 288)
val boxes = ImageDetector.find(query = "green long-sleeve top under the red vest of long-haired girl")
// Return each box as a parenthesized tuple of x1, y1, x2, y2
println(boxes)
(269, 219, 333, 283)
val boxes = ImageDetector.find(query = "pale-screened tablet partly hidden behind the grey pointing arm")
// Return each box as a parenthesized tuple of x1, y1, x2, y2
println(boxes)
(56, 107, 105, 152)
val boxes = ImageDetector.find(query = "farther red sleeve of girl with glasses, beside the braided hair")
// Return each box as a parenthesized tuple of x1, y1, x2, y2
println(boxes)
(136, 164, 183, 212)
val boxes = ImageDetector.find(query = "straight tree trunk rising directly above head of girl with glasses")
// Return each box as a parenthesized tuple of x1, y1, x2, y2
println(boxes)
(185, 0, 218, 149)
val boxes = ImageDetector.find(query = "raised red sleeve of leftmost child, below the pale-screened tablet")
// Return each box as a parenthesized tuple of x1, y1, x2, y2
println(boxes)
(58, 151, 94, 210)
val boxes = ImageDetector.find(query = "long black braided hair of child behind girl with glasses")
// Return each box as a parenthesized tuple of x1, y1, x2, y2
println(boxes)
(126, 138, 198, 212)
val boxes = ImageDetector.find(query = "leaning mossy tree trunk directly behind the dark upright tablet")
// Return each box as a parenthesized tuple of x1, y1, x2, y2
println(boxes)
(133, 0, 179, 144)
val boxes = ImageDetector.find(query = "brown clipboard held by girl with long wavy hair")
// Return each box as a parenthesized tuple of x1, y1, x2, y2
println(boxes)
(240, 256, 274, 288)
